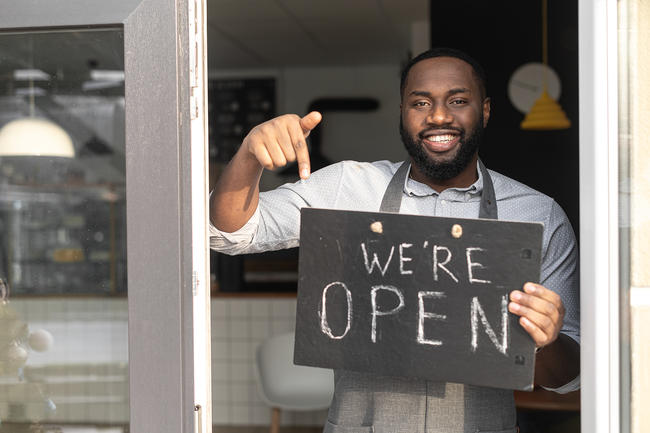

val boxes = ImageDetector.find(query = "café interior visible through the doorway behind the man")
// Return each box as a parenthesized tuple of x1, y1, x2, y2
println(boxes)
(208, 0, 580, 432)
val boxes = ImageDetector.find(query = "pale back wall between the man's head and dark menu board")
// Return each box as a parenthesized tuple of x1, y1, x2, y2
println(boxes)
(210, 65, 406, 189)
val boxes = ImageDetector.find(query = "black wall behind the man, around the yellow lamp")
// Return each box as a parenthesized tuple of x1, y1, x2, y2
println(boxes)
(431, 0, 579, 234)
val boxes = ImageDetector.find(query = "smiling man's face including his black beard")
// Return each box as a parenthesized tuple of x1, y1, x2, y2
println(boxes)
(400, 57, 490, 181)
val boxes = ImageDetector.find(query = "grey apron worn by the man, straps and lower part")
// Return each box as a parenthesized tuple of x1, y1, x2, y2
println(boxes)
(324, 160, 517, 433)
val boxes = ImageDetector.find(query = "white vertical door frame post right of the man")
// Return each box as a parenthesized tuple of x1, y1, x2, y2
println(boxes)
(578, 0, 621, 433)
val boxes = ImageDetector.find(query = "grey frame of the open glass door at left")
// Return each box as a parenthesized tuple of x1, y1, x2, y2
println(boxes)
(0, 0, 211, 433)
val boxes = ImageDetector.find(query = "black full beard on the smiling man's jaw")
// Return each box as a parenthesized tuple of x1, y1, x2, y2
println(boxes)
(399, 116, 484, 181)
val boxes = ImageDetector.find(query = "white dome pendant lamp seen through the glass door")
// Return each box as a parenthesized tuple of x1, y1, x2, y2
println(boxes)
(0, 117, 75, 158)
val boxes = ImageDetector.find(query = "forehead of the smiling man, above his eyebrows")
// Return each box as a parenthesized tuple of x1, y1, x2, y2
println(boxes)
(404, 57, 479, 96)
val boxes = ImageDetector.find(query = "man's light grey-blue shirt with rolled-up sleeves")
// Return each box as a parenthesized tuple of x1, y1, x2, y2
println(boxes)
(210, 161, 580, 431)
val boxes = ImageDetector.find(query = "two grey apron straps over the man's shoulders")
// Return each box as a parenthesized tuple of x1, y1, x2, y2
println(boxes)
(379, 159, 499, 219)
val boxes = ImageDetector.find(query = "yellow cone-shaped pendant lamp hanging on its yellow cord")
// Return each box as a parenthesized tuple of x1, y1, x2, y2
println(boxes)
(520, 0, 571, 131)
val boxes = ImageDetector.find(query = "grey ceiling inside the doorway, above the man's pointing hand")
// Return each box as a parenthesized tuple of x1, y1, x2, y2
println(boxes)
(208, 0, 429, 70)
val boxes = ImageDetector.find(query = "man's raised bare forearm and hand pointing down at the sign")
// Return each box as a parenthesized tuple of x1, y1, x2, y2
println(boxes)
(210, 111, 321, 232)
